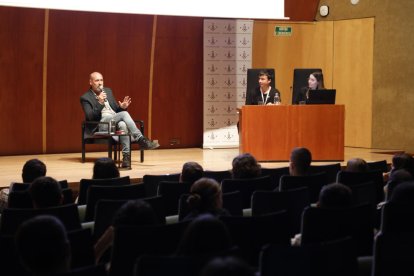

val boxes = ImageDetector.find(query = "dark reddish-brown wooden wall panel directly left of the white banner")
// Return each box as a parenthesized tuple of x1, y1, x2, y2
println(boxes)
(151, 17, 203, 147)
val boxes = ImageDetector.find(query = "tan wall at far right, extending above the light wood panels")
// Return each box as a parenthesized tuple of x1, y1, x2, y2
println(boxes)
(317, 0, 414, 153)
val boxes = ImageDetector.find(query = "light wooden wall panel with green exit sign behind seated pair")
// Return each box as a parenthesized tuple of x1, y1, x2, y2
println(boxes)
(253, 21, 333, 104)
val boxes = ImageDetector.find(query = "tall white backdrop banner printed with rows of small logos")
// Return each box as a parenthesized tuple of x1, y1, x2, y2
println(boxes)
(203, 19, 253, 148)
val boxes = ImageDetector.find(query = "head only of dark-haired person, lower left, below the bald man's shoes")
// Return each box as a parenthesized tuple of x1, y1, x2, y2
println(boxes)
(112, 199, 158, 227)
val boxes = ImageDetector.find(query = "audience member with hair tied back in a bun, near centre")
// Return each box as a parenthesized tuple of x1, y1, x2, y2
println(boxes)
(184, 178, 230, 220)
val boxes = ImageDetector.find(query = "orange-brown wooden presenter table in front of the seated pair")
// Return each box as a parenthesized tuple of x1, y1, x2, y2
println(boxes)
(239, 105, 345, 161)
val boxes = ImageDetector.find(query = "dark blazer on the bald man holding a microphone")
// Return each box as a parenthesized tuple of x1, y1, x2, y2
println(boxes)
(80, 87, 124, 136)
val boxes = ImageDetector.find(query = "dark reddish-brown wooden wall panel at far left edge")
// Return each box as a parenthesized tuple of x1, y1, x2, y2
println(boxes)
(0, 7, 45, 155)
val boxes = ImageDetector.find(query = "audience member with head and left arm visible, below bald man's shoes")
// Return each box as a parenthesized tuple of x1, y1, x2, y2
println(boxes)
(95, 199, 159, 263)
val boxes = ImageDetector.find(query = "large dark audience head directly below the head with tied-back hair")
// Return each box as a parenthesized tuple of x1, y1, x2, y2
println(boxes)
(177, 214, 232, 261)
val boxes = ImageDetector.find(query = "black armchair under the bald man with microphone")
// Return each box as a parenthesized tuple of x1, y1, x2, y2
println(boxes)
(82, 120, 144, 163)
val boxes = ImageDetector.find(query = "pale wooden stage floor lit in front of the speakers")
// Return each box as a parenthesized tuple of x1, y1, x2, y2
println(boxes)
(0, 147, 398, 190)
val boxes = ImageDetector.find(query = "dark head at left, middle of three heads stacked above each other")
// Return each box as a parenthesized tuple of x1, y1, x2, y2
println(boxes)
(29, 176, 63, 208)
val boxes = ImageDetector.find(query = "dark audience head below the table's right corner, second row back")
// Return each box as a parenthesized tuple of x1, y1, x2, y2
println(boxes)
(317, 183, 352, 209)
